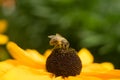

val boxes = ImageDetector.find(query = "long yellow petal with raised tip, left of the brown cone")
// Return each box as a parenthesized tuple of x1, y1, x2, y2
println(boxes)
(7, 42, 45, 68)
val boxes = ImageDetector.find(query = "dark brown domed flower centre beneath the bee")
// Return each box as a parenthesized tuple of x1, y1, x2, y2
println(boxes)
(46, 48, 82, 77)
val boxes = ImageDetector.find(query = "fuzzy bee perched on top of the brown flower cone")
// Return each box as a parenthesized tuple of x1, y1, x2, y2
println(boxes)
(48, 34, 69, 49)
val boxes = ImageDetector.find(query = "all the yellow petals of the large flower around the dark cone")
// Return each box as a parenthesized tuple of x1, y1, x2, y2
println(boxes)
(0, 42, 120, 80)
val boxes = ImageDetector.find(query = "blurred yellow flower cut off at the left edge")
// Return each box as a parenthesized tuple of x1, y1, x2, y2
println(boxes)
(0, 20, 8, 44)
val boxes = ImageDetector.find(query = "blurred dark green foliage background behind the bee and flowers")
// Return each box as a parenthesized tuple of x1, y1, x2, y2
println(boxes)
(0, 0, 120, 68)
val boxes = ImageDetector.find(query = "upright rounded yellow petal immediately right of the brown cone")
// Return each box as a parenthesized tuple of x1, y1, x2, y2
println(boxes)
(78, 48, 94, 66)
